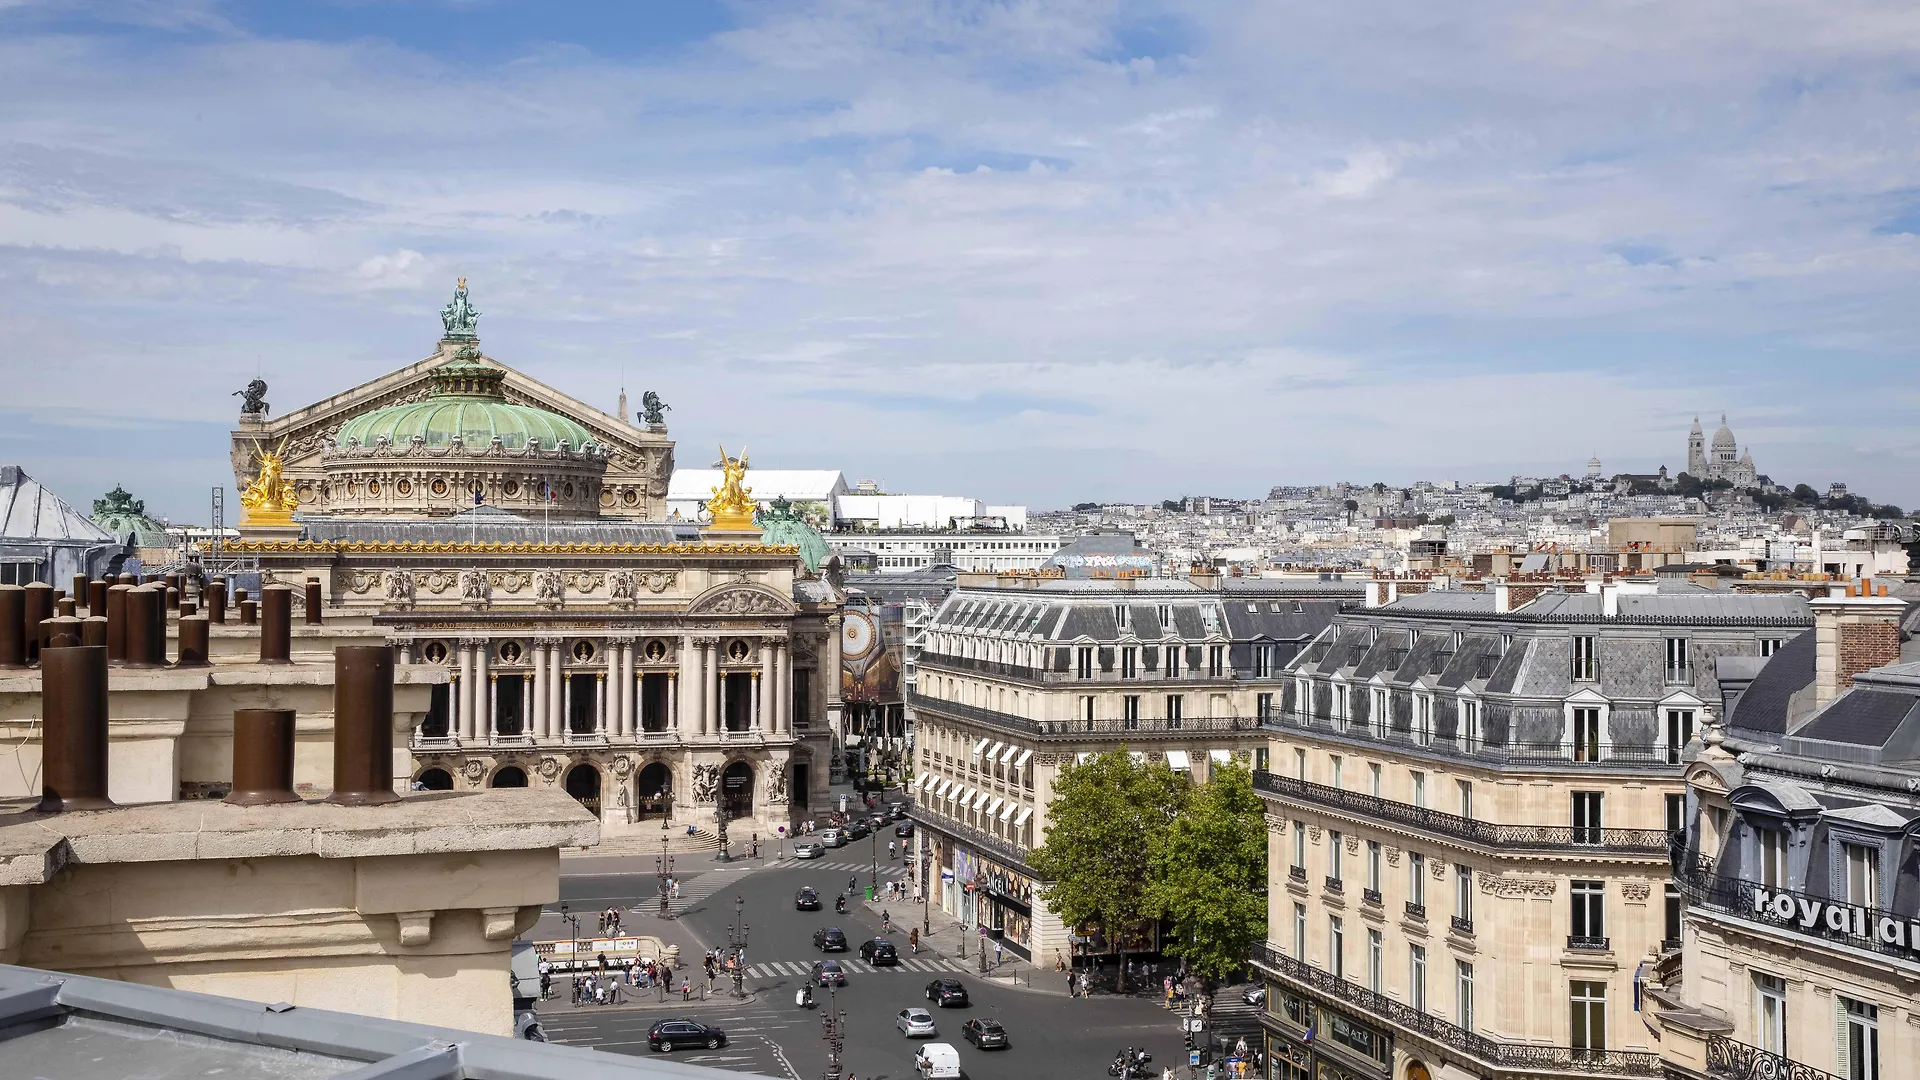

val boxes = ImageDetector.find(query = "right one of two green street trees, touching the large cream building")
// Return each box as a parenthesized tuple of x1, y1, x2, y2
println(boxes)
(1148, 765, 1267, 982)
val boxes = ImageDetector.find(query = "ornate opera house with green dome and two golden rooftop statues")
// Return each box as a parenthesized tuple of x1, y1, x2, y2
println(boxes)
(230, 288, 839, 840)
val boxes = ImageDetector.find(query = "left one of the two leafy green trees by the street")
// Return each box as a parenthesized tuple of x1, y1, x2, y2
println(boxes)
(1027, 748, 1188, 990)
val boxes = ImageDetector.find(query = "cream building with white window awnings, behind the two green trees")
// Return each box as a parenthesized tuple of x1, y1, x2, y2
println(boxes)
(908, 575, 1359, 963)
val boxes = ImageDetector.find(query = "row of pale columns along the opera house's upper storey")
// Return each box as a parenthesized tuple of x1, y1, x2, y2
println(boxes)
(437, 634, 793, 742)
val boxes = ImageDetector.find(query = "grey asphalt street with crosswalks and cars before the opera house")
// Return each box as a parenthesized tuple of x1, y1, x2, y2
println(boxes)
(532, 847, 1185, 1080)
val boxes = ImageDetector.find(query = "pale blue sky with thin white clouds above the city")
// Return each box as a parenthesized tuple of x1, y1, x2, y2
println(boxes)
(0, 0, 1920, 521)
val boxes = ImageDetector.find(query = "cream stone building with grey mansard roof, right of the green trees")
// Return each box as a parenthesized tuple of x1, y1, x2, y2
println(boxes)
(1254, 582, 1811, 1080)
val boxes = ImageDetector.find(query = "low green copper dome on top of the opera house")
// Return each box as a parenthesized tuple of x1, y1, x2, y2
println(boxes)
(334, 359, 595, 450)
